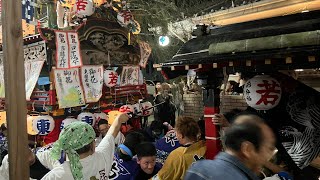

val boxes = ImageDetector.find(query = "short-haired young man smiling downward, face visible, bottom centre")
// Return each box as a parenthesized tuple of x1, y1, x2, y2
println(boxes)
(135, 142, 162, 180)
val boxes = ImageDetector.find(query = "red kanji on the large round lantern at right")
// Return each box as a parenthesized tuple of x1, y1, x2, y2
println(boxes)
(256, 80, 281, 105)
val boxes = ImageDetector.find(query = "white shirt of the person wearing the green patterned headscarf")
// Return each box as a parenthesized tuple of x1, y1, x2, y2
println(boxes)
(42, 134, 115, 180)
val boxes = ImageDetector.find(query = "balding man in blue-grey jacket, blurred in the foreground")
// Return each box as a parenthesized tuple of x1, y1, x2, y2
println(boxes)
(185, 115, 275, 180)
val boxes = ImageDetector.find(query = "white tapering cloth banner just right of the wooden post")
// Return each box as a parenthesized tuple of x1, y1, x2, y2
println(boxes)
(24, 60, 44, 101)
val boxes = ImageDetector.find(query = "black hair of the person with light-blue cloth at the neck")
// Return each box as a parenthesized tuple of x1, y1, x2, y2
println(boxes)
(123, 131, 146, 155)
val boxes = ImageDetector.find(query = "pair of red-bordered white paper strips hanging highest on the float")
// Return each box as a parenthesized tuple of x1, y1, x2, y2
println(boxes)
(55, 31, 82, 69)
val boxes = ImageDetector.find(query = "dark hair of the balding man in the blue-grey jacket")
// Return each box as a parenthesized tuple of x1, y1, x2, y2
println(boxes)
(222, 122, 264, 152)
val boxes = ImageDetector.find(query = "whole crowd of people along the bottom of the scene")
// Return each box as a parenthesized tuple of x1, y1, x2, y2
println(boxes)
(0, 107, 302, 180)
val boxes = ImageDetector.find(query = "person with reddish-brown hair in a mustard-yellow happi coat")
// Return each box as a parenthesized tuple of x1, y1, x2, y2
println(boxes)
(152, 117, 206, 180)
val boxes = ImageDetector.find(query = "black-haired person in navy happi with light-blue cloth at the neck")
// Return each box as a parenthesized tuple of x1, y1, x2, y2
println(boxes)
(109, 131, 145, 180)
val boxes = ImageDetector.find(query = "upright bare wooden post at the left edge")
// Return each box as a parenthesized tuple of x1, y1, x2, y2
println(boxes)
(1, 0, 29, 180)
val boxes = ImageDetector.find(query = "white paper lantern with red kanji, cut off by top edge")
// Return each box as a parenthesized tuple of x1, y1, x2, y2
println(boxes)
(74, 0, 94, 18)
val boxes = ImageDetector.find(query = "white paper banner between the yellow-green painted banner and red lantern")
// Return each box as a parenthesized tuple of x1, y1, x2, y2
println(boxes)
(81, 65, 103, 103)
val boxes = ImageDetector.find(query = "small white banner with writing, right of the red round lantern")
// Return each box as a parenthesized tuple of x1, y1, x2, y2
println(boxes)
(120, 66, 141, 86)
